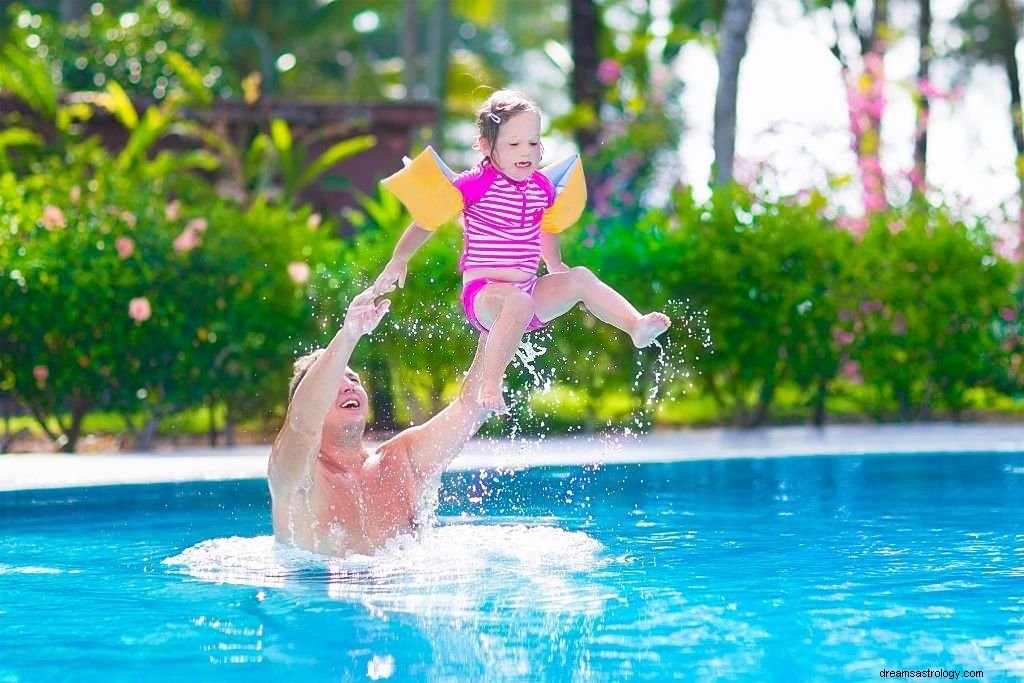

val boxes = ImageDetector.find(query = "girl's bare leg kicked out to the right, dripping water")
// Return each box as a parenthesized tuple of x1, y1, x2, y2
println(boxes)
(536, 266, 672, 344)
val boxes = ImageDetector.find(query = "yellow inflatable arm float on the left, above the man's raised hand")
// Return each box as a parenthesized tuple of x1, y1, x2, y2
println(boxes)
(381, 146, 462, 230)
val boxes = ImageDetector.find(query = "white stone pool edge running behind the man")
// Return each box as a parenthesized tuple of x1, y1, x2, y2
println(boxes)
(0, 423, 1024, 490)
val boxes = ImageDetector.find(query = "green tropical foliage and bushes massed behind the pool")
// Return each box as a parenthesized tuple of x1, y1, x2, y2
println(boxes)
(0, 0, 1024, 451)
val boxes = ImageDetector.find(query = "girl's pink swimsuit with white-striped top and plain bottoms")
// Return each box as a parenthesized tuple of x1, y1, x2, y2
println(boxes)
(452, 160, 555, 332)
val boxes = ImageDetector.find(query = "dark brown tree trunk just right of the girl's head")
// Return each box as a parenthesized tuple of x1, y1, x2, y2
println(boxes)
(569, 0, 602, 155)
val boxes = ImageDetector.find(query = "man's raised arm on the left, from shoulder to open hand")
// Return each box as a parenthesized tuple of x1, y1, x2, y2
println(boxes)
(268, 289, 391, 490)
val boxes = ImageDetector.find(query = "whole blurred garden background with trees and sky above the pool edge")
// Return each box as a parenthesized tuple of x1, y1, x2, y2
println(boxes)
(0, 0, 1024, 452)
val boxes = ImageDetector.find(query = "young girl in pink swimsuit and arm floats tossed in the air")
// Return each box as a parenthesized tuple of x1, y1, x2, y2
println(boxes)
(374, 90, 671, 413)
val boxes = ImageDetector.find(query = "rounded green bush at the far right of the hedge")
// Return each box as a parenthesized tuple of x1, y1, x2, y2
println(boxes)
(837, 202, 1014, 420)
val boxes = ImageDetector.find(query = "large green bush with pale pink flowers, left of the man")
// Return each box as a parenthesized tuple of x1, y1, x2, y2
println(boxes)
(0, 143, 338, 450)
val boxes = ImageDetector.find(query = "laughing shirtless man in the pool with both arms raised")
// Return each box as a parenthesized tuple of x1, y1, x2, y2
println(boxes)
(267, 289, 488, 556)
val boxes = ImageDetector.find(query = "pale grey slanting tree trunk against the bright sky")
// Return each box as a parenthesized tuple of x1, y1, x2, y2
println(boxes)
(714, 0, 757, 185)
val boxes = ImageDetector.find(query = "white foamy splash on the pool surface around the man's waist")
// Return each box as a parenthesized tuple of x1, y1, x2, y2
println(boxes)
(163, 523, 612, 617)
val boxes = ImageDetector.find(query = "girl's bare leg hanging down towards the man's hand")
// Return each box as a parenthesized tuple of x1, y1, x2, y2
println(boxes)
(474, 284, 534, 413)
